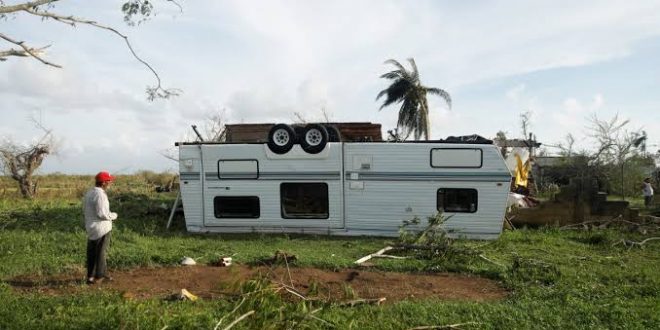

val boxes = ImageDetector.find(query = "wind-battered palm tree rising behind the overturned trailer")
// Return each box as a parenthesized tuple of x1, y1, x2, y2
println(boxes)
(376, 58, 451, 140)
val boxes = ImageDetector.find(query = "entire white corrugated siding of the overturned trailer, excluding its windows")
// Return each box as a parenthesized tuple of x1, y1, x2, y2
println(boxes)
(180, 143, 510, 239)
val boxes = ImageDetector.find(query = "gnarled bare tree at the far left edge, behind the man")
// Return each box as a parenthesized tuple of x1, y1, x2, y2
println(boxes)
(0, 119, 55, 198)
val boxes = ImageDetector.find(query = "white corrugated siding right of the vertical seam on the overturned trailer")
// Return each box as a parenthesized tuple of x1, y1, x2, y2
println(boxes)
(344, 143, 509, 237)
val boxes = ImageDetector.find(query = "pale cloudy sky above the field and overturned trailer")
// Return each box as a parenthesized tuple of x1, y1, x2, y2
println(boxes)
(0, 0, 660, 174)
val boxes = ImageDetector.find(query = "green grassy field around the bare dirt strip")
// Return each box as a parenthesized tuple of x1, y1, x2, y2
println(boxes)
(0, 177, 660, 329)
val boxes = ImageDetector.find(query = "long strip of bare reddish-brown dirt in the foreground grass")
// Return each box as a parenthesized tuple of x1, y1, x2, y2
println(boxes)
(7, 265, 507, 302)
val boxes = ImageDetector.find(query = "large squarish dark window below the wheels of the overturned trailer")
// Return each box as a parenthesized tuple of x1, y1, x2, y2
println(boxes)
(280, 182, 329, 219)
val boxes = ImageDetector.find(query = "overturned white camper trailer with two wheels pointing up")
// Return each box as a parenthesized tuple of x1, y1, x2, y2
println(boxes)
(176, 124, 511, 239)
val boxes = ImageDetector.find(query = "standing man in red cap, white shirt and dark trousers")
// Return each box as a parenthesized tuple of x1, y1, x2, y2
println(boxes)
(83, 172, 117, 284)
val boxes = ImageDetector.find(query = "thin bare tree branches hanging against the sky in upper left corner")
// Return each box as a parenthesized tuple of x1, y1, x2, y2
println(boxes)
(0, 0, 181, 101)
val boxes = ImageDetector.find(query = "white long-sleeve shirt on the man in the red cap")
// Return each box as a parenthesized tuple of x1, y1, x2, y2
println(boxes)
(83, 187, 117, 240)
